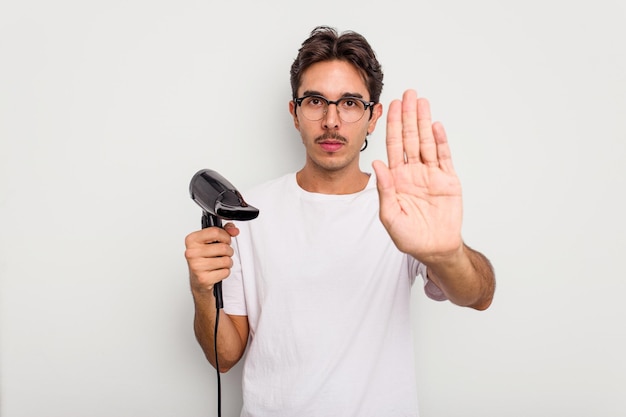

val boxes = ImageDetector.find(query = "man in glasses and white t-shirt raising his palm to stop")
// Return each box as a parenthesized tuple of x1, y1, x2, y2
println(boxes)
(185, 27, 495, 417)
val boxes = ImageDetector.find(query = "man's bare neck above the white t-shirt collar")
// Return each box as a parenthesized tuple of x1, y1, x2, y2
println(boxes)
(296, 166, 370, 194)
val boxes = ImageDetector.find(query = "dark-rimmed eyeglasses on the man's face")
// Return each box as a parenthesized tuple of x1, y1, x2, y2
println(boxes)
(293, 95, 376, 123)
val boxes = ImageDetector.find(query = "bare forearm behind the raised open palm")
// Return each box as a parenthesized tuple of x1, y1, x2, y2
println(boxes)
(426, 244, 495, 310)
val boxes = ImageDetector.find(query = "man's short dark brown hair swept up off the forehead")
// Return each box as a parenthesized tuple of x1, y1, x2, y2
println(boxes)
(290, 26, 383, 103)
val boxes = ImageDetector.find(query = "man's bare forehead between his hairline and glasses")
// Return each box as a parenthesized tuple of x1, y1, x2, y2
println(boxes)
(298, 60, 369, 99)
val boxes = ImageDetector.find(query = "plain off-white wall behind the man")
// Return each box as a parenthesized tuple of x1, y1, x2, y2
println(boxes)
(0, 0, 626, 417)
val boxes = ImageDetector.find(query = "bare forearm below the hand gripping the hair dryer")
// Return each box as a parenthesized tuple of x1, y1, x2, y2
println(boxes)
(193, 292, 248, 372)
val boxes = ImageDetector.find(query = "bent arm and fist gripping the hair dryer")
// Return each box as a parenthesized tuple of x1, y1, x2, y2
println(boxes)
(185, 223, 249, 372)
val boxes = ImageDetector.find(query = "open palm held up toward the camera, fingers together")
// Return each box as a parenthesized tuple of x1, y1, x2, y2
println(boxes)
(373, 90, 463, 263)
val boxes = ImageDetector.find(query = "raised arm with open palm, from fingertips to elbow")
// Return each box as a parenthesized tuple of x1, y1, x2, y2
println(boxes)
(373, 90, 495, 310)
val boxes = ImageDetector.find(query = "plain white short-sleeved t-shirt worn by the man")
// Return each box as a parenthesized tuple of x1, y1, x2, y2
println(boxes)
(223, 173, 444, 417)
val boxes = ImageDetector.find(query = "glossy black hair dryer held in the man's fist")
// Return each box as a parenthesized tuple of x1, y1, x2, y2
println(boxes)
(189, 169, 259, 309)
